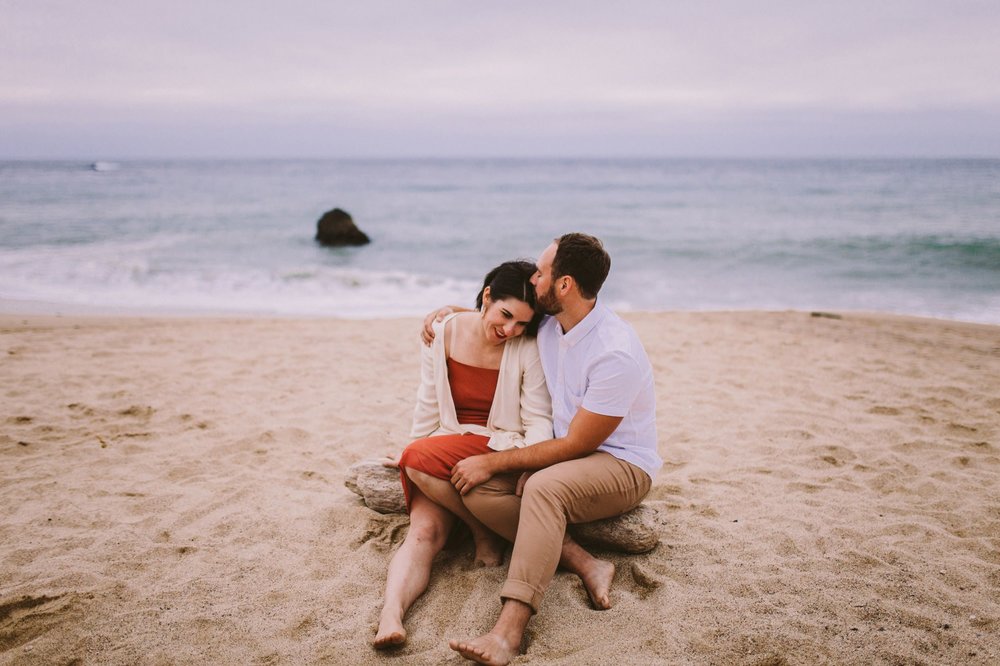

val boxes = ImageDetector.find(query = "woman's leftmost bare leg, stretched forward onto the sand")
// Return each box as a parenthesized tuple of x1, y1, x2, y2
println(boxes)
(373, 488, 455, 648)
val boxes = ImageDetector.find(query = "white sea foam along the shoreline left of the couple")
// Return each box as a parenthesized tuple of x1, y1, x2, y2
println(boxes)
(0, 247, 477, 318)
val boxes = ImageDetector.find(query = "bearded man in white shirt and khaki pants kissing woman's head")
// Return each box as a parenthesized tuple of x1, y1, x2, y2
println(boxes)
(426, 233, 662, 664)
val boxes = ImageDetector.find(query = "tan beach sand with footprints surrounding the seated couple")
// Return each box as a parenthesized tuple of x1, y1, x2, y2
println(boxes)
(0, 312, 1000, 665)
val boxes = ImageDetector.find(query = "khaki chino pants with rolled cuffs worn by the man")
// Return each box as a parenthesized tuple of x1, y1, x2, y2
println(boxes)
(463, 451, 651, 612)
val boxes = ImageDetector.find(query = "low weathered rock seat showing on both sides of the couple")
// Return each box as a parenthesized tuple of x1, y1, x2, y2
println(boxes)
(344, 460, 659, 553)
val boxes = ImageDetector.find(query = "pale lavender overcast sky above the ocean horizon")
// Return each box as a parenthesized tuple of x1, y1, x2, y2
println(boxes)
(0, 0, 1000, 159)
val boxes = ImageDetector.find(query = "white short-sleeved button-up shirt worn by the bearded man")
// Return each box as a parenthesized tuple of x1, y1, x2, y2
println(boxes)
(538, 303, 663, 478)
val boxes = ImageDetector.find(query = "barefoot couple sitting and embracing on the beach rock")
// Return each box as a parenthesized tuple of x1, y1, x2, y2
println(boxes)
(374, 233, 662, 664)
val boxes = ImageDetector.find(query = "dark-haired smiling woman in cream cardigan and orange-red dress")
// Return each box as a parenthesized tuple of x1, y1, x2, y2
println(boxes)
(374, 261, 552, 648)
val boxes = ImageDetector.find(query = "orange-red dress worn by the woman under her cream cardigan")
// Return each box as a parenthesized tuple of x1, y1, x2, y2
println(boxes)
(399, 358, 500, 510)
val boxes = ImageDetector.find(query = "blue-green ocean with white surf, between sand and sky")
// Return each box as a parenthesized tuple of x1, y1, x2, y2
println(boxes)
(0, 159, 1000, 324)
